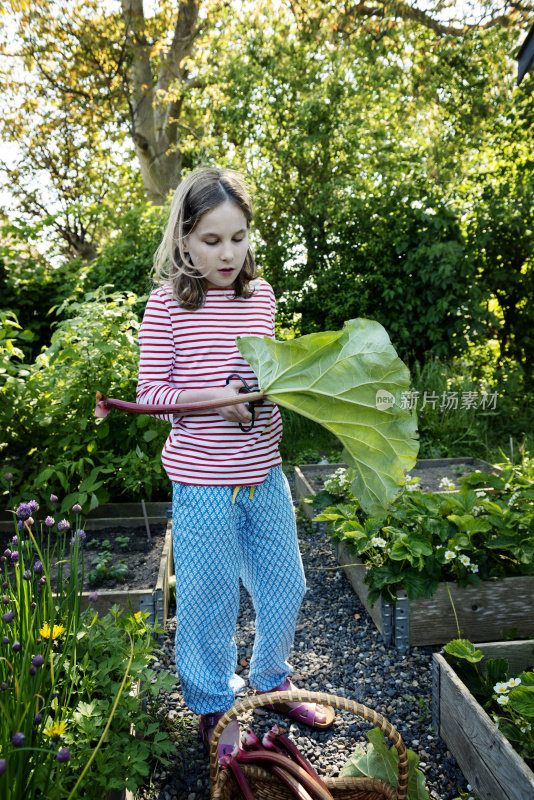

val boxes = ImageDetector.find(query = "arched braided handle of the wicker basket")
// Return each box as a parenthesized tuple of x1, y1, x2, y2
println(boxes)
(210, 689, 408, 800)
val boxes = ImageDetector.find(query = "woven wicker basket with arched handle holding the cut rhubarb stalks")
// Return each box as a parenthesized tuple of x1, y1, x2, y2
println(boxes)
(210, 690, 408, 800)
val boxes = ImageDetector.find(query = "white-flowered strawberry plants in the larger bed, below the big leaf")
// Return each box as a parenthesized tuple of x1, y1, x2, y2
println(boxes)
(315, 467, 534, 604)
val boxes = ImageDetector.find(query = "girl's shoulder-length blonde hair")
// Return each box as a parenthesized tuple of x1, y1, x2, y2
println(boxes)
(153, 167, 256, 311)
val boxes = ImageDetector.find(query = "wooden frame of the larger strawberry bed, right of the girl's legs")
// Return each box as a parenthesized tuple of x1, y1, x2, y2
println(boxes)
(295, 458, 534, 650)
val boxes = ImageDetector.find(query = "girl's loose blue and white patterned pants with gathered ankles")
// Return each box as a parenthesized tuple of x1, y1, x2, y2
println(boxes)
(173, 466, 306, 714)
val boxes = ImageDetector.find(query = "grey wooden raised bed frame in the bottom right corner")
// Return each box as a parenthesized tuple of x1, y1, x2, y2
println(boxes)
(432, 639, 534, 800)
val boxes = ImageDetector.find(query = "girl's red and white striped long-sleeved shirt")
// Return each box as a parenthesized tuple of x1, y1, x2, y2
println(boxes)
(137, 279, 282, 486)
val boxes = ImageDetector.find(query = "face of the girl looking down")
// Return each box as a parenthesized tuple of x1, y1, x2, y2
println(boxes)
(184, 200, 248, 289)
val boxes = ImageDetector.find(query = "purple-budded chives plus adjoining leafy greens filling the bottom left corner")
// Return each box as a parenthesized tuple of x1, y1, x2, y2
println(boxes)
(0, 503, 180, 800)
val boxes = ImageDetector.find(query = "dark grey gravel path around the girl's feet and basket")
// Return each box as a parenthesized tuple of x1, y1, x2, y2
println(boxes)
(140, 482, 466, 800)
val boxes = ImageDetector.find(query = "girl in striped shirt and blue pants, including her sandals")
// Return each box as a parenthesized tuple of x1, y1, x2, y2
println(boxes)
(137, 169, 334, 755)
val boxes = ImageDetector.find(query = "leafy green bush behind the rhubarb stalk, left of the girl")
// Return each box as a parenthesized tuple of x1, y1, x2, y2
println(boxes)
(0, 288, 167, 509)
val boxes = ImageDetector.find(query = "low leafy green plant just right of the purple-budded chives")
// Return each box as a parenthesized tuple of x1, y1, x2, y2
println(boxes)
(58, 607, 176, 800)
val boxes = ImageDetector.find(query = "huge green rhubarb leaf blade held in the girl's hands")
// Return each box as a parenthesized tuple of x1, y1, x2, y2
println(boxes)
(237, 319, 419, 516)
